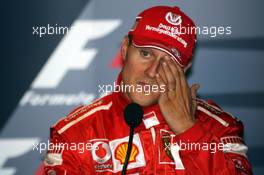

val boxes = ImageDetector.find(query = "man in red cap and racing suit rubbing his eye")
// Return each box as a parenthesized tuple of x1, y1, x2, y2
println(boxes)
(44, 6, 252, 175)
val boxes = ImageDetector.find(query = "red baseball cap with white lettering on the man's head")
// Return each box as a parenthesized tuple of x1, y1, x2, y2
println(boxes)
(128, 6, 196, 68)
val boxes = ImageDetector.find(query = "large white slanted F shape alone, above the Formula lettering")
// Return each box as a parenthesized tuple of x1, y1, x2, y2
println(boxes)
(31, 20, 121, 89)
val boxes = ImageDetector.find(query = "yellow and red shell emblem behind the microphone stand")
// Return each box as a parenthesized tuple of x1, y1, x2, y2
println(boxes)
(115, 142, 139, 164)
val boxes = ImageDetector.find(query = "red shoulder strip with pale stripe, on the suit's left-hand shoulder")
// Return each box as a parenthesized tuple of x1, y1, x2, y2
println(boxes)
(51, 94, 112, 134)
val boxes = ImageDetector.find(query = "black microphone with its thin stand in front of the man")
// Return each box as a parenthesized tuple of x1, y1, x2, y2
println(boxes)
(122, 103, 144, 175)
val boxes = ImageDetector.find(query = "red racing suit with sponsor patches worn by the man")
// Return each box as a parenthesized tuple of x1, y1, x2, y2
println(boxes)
(44, 85, 252, 175)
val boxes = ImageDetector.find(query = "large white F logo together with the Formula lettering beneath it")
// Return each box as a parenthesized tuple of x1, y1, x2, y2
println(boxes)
(19, 20, 121, 106)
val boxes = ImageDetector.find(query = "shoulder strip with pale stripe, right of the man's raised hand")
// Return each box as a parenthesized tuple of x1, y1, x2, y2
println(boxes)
(196, 99, 242, 127)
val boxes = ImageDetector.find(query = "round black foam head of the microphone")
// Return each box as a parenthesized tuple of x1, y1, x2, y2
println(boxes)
(124, 103, 144, 128)
